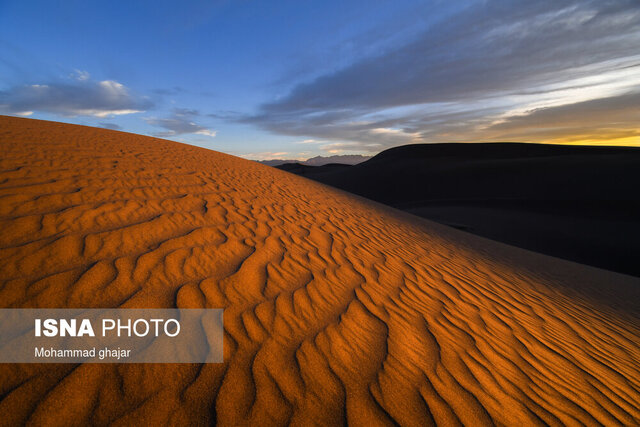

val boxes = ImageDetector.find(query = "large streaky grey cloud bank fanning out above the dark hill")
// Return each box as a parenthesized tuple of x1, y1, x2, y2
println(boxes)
(240, 0, 640, 151)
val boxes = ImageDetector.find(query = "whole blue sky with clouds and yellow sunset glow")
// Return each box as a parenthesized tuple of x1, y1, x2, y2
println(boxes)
(0, 0, 640, 160)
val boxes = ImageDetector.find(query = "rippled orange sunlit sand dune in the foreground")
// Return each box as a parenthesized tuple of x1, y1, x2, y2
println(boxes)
(0, 117, 640, 426)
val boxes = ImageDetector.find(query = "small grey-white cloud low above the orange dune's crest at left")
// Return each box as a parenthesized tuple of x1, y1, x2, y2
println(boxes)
(0, 77, 153, 117)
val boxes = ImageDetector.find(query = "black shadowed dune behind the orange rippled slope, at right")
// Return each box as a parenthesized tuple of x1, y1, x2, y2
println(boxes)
(282, 143, 640, 276)
